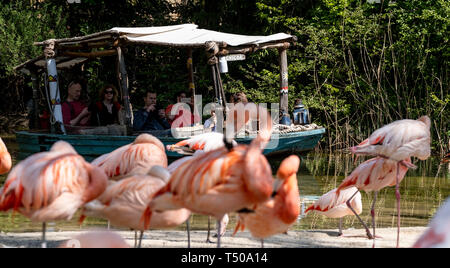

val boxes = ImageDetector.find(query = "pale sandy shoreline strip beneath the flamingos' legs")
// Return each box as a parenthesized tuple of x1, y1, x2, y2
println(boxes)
(0, 227, 427, 248)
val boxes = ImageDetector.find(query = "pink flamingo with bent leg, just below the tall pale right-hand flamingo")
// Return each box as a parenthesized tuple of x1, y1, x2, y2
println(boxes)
(336, 156, 412, 246)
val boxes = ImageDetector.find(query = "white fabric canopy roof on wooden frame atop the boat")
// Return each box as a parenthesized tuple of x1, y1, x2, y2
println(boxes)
(15, 24, 296, 74)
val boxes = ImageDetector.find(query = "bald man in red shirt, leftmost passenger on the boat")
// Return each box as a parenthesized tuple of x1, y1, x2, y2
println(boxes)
(61, 81, 91, 126)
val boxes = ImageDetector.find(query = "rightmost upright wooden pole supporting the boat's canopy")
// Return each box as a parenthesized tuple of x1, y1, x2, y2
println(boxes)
(278, 47, 291, 125)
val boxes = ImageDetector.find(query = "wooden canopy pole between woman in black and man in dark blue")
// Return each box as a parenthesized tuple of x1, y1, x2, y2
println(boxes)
(116, 46, 133, 135)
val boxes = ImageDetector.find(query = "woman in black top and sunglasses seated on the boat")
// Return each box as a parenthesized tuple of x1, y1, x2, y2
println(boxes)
(89, 85, 122, 126)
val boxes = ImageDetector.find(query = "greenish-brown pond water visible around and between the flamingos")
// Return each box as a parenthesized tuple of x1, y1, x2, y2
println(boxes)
(0, 138, 450, 232)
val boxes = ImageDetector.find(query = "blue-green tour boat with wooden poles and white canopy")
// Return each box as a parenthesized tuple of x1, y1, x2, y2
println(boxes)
(15, 24, 325, 160)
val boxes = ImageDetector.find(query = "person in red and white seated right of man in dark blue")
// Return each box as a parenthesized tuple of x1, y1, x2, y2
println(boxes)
(166, 92, 200, 128)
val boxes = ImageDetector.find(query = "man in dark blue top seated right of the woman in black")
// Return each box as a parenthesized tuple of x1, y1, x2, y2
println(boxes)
(133, 92, 170, 131)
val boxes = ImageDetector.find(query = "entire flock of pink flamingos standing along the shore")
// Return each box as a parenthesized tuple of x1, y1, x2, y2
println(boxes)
(0, 103, 450, 247)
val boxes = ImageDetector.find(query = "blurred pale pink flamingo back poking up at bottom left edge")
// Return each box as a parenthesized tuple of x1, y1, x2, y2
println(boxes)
(59, 231, 130, 248)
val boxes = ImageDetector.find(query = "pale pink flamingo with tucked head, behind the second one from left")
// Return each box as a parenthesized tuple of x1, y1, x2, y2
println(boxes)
(92, 134, 167, 180)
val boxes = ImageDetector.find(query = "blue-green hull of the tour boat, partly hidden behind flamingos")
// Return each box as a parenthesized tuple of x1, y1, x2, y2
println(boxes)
(16, 128, 325, 161)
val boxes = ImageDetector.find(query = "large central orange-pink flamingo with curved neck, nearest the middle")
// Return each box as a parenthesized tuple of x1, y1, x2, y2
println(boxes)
(147, 104, 273, 247)
